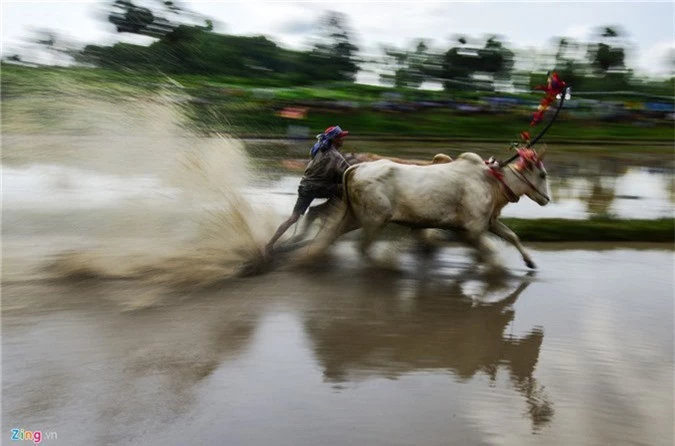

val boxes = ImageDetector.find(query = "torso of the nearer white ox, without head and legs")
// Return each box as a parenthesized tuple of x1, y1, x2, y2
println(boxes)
(344, 153, 499, 230)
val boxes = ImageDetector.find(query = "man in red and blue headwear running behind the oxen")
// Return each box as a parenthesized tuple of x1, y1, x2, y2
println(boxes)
(265, 125, 350, 254)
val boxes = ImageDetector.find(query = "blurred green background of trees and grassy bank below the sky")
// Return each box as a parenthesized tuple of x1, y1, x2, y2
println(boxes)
(2, 0, 675, 141)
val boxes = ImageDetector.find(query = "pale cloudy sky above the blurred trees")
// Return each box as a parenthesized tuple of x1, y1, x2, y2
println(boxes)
(1, 0, 675, 81)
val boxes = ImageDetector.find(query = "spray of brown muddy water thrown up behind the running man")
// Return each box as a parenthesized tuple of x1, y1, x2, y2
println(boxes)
(3, 86, 276, 290)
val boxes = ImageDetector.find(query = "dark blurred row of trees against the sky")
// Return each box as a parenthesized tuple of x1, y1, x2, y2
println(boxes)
(15, 0, 672, 91)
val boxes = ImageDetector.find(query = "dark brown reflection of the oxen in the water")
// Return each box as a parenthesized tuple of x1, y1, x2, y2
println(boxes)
(305, 275, 554, 430)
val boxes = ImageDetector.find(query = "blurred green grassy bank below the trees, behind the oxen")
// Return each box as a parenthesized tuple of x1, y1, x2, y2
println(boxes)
(2, 64, 675, 145)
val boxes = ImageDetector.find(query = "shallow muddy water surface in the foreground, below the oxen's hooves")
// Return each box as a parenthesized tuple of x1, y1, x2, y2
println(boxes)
(2, 243, 673, 445)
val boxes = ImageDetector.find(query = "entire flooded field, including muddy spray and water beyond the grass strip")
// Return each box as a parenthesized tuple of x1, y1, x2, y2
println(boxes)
(0, 98, 675, 446)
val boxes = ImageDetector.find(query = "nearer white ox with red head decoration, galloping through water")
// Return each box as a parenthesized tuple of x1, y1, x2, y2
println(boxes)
(315, 149, 550, 268)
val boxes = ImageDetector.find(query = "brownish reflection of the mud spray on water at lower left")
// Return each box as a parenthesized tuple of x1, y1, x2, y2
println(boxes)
(3, 281, 258, 444)
